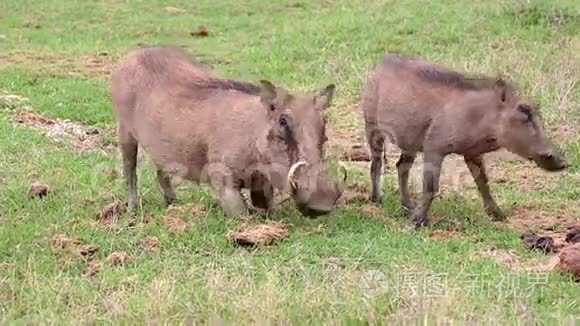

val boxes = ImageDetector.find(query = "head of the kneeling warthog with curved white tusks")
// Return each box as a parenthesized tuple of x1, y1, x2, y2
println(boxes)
(260, 80, 346, 217)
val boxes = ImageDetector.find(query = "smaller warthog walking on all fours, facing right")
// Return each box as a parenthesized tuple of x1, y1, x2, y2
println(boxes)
(361, 55, 565, 227)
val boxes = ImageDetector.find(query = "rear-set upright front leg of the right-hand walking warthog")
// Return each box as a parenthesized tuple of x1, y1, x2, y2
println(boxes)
(413, 152, 444, 227)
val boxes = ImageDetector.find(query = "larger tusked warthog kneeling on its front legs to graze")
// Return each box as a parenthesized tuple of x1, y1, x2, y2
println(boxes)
(111, 47, 346, 216)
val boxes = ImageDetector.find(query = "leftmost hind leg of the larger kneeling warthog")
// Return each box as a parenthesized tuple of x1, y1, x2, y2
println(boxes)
(119, 130, 138, 211)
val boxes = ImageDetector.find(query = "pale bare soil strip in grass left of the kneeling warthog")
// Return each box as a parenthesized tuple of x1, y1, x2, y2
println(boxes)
(14, 109, 115, 153)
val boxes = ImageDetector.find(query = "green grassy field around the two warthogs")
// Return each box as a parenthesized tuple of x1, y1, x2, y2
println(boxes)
(0, 0, 580, 325)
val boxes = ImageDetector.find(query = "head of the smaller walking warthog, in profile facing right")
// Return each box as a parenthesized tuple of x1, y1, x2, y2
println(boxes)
(496, 79, 566, 171)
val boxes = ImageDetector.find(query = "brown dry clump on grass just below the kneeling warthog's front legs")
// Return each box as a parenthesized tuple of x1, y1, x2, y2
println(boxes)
(227, 222, 289, 245)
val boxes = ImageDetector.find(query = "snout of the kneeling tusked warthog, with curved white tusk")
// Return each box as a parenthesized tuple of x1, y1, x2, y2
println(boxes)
(288, 161, 348, 218)
